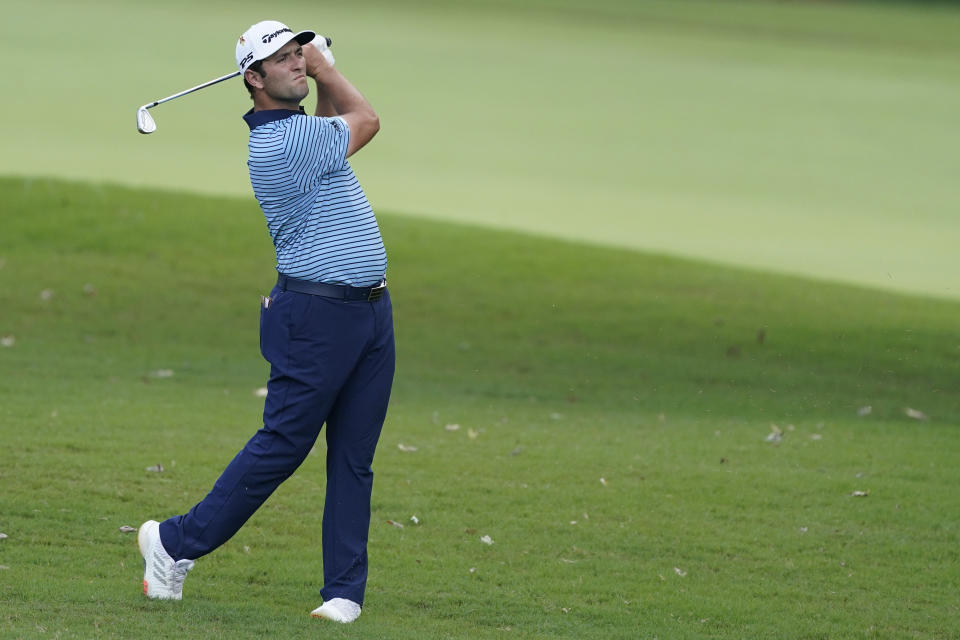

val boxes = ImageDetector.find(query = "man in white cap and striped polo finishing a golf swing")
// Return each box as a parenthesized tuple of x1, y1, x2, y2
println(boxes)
(137, 21, 394, 622)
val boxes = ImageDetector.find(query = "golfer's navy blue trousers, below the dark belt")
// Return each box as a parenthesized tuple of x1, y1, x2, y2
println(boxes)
(160, 288, 395, 604)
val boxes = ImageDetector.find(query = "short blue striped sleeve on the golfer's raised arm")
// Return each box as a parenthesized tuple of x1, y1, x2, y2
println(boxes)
(284, 115, 350, 191)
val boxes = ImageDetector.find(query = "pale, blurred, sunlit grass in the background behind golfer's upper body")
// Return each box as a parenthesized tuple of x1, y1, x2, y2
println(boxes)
(0, 0, 960, 298)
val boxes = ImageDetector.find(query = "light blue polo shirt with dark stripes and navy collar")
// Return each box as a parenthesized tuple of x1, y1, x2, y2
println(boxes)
(243, 107, 387, 287)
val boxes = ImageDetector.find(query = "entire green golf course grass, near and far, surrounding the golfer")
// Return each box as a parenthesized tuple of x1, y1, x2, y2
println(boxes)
(0, 0, 960, 639)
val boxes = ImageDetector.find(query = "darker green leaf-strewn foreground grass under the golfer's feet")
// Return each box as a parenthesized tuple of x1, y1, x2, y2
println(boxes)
(0, 179, 960, 639)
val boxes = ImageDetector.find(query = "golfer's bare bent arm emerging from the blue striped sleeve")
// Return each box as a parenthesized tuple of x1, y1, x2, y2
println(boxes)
(303, 44, 380, 158)
